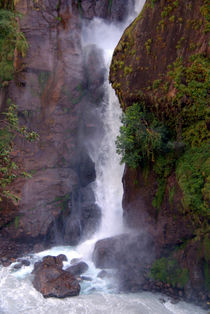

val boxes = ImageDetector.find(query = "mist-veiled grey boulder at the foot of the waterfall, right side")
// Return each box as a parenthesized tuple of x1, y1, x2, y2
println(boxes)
(93, 232, 155, 291)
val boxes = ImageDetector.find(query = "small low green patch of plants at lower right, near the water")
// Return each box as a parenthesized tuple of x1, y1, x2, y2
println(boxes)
(150, 257, 189, 288)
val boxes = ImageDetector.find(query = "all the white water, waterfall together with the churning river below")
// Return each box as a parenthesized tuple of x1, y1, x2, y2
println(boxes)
(0, 0, 206, 314)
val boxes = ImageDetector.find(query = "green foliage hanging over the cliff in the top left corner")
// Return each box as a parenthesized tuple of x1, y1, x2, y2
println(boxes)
(0, 0, 28, 86)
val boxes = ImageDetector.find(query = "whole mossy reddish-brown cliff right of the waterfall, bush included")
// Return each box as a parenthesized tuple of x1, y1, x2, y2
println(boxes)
(110, 0, 210, 300)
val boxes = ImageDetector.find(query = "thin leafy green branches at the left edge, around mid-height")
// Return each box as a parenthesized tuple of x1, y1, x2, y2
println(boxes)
(0, 100, 38, 202)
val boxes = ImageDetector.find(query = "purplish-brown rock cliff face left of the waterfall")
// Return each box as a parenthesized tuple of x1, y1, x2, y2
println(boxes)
(0, 0, 129, 256)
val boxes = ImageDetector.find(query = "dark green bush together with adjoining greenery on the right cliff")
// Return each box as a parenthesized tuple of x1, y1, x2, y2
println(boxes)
(116, 55, 210, 220)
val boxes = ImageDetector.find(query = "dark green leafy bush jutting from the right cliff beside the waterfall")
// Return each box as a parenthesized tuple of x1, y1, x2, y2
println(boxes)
(116, 104, 166, 168)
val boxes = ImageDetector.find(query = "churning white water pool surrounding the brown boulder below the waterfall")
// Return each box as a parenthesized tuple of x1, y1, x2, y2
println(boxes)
(0, 247, 206, 314)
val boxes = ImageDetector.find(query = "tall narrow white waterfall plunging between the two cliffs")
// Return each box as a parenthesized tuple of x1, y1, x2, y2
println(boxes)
(81, 18, 124, 239)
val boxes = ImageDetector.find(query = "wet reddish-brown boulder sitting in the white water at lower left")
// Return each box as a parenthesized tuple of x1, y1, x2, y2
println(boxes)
(33, 256, 80, 298)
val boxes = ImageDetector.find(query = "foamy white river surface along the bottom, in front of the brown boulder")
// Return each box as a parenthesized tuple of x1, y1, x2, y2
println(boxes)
(0, 262, 207, 314)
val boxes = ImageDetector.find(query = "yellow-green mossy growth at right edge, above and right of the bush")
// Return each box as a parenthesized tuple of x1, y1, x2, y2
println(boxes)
(166, 55, 210, 147)
